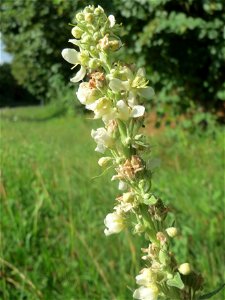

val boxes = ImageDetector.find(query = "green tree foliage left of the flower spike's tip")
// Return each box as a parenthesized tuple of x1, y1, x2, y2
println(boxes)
(1, 0, 82, 98)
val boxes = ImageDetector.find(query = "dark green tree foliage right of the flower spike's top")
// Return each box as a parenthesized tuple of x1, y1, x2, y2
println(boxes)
(114, 0, 225, 116)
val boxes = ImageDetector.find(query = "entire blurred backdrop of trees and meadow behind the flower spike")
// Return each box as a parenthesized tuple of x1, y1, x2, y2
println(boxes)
(0, 0, 225, 300)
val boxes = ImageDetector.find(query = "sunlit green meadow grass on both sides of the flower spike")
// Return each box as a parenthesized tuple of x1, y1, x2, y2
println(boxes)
(0, 107, 224, 300)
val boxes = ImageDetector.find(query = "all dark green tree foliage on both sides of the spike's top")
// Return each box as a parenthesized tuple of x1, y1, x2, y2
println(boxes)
(1, 0, 225, 116)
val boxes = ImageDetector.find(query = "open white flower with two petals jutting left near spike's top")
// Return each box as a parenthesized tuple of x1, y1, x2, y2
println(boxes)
(62, 48, 86, 82)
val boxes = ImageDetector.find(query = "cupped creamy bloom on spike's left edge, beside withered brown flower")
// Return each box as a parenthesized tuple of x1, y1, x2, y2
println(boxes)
(76, 82, 99, 108)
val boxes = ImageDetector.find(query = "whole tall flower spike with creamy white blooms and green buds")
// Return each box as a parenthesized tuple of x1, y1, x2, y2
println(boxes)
(62, 6, 206, 300)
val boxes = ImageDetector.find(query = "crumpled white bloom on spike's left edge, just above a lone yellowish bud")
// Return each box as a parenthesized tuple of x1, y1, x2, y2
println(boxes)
(91, 127, 113, 153)
